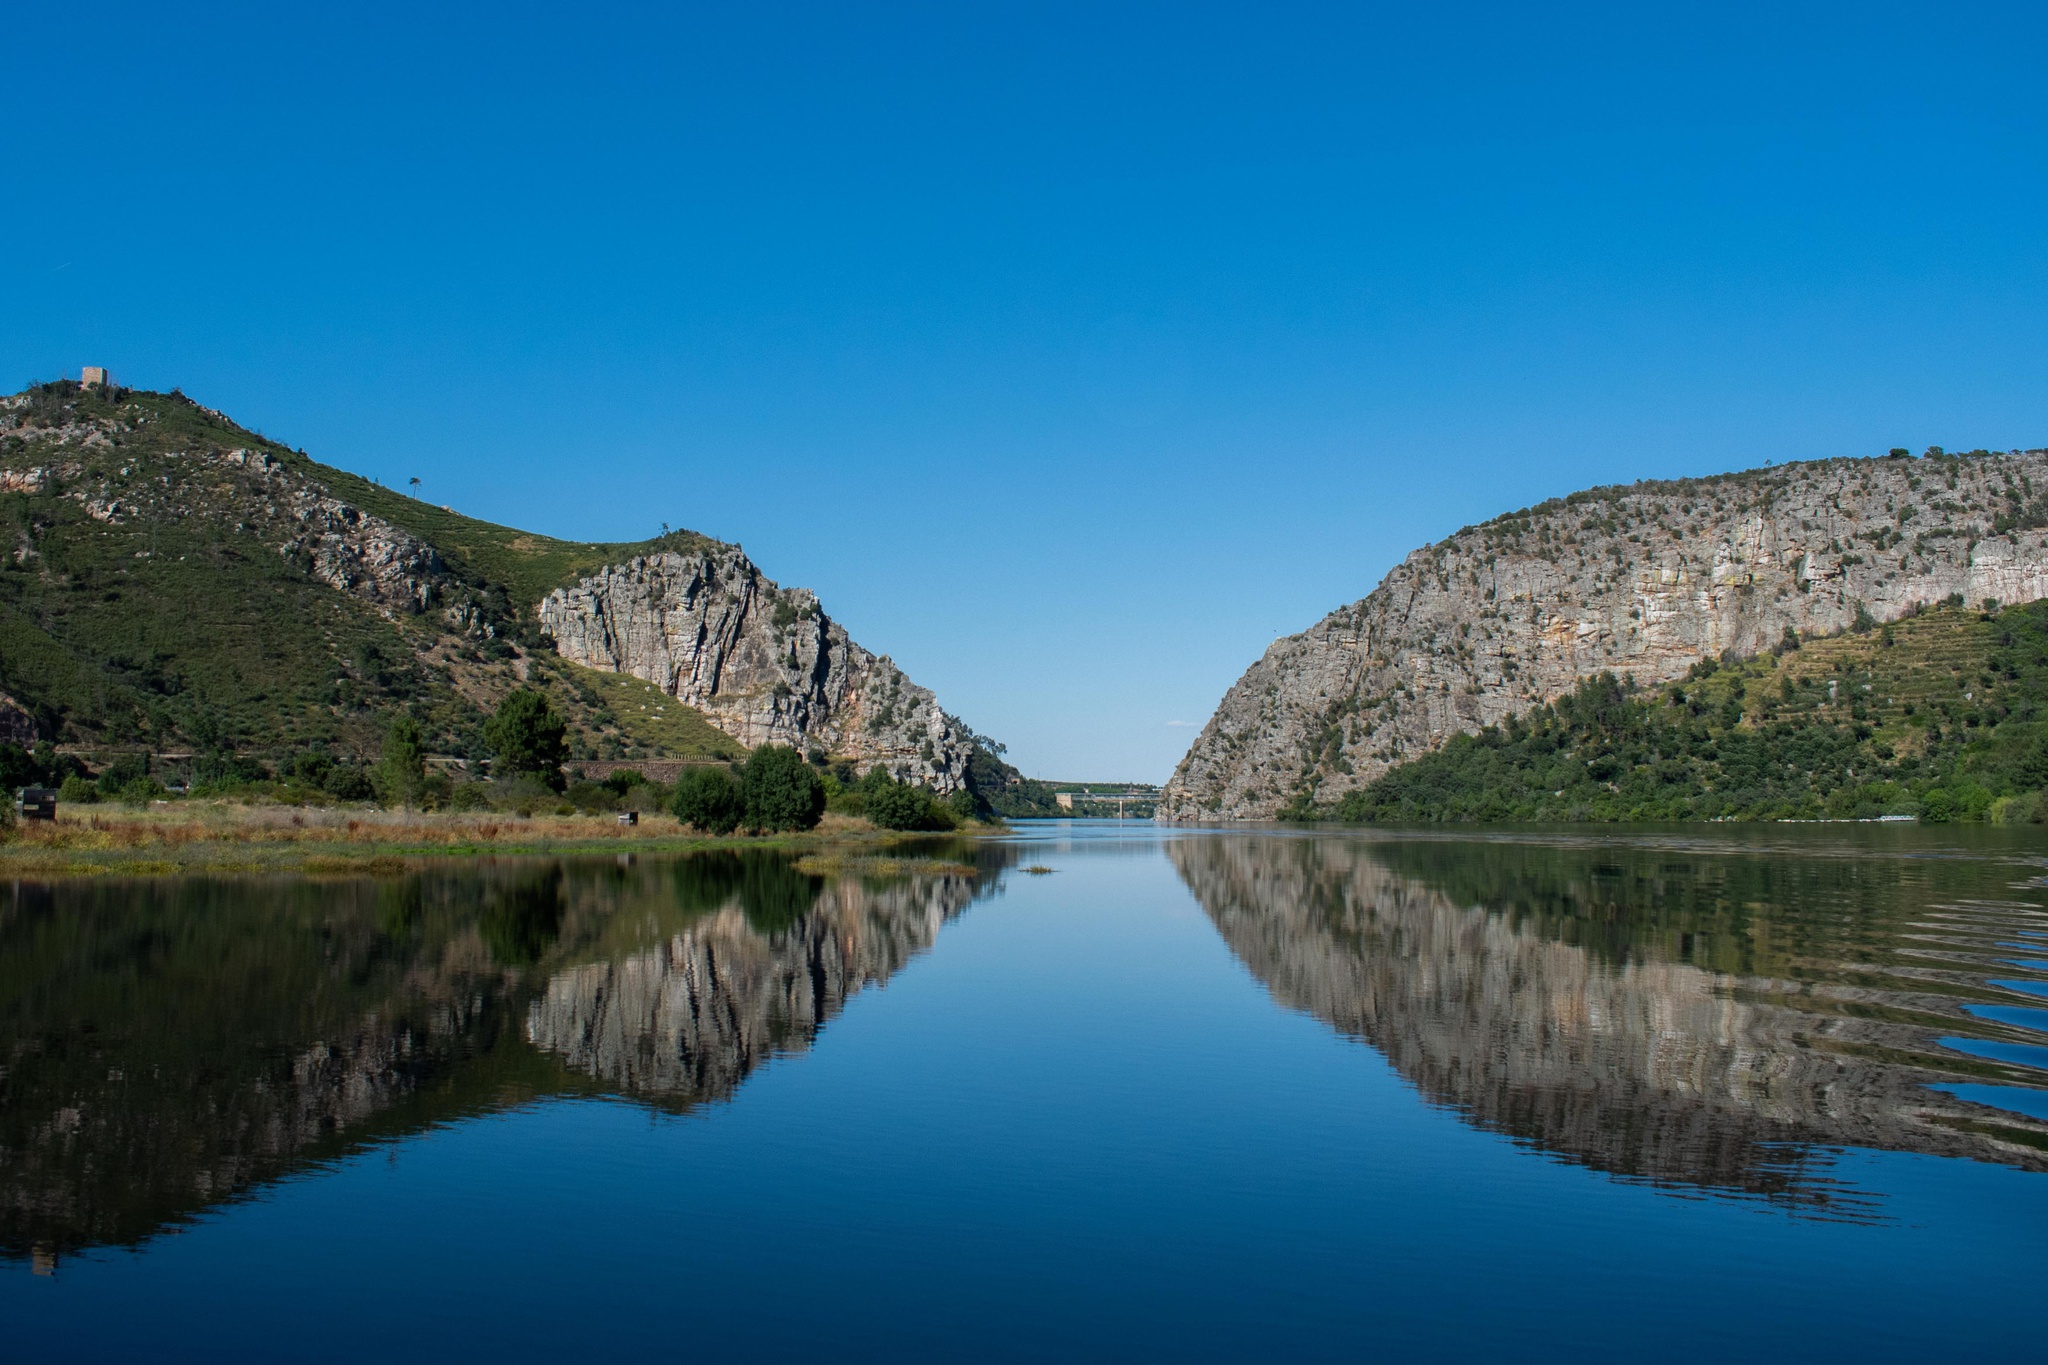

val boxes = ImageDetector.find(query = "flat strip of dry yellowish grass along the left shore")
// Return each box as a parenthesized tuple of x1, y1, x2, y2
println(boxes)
(0, 800, 999, 878)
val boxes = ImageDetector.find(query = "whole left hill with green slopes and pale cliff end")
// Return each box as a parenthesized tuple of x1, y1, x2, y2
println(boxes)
(0, 381, 1014, 792)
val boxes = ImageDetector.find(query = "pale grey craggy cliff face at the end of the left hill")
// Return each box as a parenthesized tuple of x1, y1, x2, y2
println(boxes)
(541, 546, 973, 794)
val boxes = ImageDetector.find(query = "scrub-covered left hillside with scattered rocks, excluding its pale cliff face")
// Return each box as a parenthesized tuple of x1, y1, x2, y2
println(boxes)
(0, 381, 1022, 808)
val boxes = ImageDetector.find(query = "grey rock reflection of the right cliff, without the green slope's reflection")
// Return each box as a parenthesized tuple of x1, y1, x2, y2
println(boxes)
(1167, 837, 2048, 1203)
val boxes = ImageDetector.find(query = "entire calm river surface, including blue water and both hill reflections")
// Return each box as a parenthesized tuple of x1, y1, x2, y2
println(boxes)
(0, 823, 2048, 1361)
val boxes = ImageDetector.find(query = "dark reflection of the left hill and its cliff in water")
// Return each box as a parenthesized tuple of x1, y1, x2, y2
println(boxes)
(0, 845, 1016, 1267)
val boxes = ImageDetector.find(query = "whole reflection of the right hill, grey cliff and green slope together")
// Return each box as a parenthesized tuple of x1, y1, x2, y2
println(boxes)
(1167, 835, 2048, 1218)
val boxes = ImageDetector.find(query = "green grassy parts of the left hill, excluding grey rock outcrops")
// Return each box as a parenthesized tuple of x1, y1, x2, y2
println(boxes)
(0, 385, 735, 757)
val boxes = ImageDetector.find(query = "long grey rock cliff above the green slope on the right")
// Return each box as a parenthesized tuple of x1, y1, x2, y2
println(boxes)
(1159, 450, 2048, 821)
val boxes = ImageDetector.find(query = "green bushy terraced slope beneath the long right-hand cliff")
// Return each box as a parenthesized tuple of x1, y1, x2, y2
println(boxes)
(1335, 604, 2048, 823)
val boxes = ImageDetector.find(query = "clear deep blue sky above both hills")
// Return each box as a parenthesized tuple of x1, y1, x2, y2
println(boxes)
(0, 4, 2048, 780)
